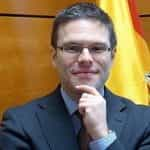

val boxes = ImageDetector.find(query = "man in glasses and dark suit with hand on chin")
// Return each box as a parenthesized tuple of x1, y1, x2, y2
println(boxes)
(0, 3, 150, 150)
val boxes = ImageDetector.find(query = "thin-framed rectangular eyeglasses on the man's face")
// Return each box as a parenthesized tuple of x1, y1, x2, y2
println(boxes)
(57, 44, 111, 54)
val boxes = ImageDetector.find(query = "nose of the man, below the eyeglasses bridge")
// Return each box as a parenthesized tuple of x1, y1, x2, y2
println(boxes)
(78, 48, 93, 65)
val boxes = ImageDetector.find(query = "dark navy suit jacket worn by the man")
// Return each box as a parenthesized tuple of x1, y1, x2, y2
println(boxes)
(0, 88, 150, 150)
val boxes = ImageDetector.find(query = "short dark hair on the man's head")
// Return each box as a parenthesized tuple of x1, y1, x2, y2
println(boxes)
(51, 2, 117, 49)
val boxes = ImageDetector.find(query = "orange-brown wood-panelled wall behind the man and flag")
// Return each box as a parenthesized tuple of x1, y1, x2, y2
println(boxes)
(0, 0, 150, 117)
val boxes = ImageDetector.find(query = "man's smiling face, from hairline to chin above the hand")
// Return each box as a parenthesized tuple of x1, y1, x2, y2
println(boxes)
(53, 19, 115, 91)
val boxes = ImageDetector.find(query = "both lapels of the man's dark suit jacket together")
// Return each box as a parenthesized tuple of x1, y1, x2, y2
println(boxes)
(36, 87, 127, 150)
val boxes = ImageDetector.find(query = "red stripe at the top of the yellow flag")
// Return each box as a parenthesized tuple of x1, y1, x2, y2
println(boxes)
(128, 0, 143, 36)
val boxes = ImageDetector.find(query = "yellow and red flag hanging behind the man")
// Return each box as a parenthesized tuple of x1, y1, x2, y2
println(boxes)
(97, 0, 150, 105)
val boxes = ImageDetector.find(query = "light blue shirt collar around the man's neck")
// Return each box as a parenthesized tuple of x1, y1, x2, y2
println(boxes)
(61, 87, 104, 115)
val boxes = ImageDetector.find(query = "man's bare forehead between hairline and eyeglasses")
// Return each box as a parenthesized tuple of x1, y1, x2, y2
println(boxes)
(57, 19, 110, 46)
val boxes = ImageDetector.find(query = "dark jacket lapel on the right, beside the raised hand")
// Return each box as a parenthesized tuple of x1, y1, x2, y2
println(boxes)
(104, 89, 127, 138)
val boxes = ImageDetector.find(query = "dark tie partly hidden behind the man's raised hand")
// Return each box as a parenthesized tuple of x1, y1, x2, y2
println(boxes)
(75, 111, 90, 150)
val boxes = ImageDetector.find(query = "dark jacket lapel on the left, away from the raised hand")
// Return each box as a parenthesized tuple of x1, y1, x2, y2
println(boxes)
(37, 90, 78, 150)
